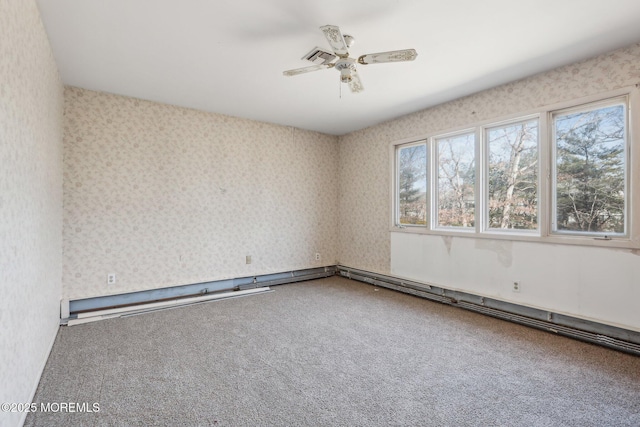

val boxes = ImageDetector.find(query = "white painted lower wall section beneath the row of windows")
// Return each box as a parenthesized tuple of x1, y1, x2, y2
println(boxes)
(391, 232, 640, 331)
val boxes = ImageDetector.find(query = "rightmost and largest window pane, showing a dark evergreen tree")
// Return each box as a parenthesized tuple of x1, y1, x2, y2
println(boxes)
(554, 104, 626, 233)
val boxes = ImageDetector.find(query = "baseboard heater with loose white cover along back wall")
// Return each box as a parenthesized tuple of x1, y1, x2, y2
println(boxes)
(60, 266, 336, 326)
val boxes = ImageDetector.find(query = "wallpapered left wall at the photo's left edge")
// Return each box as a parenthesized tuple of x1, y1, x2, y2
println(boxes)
(0, 0, 63, 426)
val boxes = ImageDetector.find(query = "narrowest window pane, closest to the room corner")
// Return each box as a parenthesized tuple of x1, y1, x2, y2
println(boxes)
(398, 144, 427, 225)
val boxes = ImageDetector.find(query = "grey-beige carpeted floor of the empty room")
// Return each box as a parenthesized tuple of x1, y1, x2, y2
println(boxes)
(25, 277, 640, 427)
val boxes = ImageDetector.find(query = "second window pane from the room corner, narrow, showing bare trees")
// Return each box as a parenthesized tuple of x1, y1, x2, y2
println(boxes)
(436, 133, 476, 228)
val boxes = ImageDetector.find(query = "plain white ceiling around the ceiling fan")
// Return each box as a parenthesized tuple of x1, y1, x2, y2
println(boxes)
(37, 0, 640, 135)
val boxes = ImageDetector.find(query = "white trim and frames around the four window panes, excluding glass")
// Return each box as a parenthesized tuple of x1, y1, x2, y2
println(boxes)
(389, 84, 640, 250)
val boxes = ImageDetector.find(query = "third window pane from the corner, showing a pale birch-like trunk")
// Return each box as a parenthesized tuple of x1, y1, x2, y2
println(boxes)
(487, 120, 538, 230)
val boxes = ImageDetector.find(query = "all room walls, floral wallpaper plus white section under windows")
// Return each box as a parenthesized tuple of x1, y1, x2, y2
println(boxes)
(0, 0, 640, 425)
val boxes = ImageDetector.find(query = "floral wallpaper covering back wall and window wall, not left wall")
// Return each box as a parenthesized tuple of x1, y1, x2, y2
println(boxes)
(63, 45, 640, 299)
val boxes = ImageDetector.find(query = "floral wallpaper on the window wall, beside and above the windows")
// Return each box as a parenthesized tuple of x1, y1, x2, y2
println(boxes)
(339, 44, 640, 274)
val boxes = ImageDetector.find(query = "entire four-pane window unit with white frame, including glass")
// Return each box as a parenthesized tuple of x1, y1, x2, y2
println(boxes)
(393, 88, 640, 248)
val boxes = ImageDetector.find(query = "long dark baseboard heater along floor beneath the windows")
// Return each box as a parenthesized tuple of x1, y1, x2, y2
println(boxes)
(336, 265, 640, 356)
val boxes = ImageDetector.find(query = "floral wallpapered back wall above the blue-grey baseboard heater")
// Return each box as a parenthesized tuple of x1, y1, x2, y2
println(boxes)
(63, 87, 338, 299)
